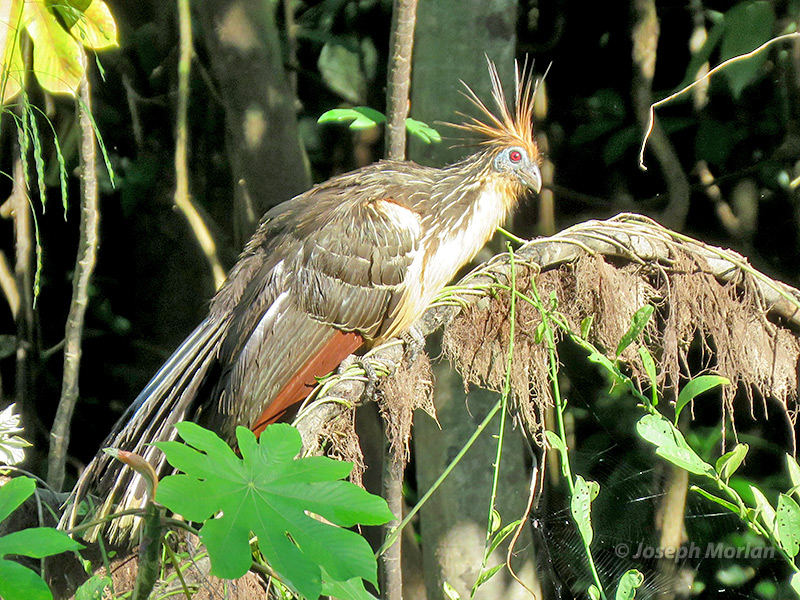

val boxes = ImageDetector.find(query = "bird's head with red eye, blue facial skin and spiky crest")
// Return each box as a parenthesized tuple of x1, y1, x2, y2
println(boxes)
(449, 57, 542, 193)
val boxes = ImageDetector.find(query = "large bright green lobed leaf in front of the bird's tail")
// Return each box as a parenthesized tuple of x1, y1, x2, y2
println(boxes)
(156, 422, 393, 598)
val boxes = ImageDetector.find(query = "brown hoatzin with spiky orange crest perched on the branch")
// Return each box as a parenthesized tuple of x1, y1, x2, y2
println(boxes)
(65, 62, 542, 538)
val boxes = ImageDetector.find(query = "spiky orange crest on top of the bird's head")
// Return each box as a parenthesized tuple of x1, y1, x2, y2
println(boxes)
(447, 57, 539, 160)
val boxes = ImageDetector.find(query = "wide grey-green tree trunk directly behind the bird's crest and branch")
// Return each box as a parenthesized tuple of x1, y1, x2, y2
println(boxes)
(409, 0, 535, 598)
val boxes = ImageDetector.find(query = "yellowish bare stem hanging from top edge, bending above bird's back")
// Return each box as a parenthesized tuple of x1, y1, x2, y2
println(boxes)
(175, 0, 225, 289)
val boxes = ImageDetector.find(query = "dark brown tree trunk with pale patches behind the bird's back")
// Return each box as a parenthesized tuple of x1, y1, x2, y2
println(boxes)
(197, 0, 311, 247)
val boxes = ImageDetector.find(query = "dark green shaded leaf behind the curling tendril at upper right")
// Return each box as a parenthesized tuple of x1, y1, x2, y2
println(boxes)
(720, 0, 775, 98)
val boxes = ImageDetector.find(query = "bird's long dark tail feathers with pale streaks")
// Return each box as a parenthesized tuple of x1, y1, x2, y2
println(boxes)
(61, 317, 225, 542)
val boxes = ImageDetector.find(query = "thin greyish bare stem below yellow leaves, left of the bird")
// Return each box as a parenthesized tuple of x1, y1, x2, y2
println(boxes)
(47, 77, 100, 490)
